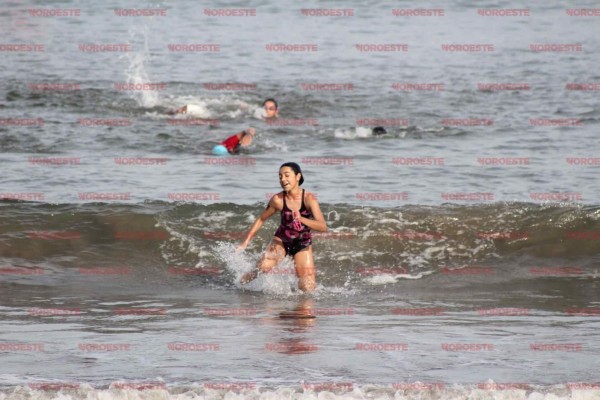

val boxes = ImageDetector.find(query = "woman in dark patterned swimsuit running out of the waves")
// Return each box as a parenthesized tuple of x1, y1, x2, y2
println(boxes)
(238, 162, 327, 292)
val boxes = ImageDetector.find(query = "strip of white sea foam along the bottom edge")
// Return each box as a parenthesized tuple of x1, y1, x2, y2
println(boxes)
(0, 380, 584, 400)
